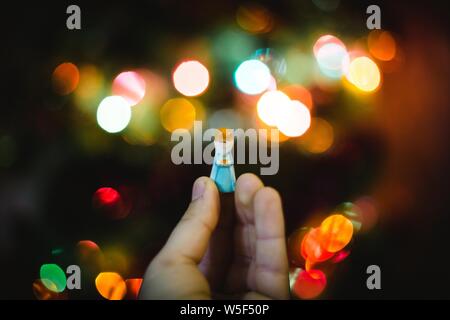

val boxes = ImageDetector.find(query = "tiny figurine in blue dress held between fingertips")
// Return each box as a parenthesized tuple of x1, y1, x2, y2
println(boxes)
(210, 129, 236, 192)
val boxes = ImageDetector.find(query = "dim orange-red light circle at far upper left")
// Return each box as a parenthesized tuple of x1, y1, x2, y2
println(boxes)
(52, 62, 80, 95)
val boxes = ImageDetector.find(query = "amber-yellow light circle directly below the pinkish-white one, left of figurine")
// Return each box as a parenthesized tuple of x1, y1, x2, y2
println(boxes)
(160, 98, 196, 132)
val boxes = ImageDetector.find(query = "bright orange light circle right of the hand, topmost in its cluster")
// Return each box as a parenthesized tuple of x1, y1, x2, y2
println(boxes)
(319, 214, 353, 252)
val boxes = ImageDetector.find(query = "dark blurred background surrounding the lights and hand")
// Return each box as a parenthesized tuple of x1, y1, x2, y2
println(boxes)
(0, 0, 450, 299)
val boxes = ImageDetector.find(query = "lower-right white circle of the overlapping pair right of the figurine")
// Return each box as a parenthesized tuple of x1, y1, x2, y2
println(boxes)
(277, 100, 311, 137)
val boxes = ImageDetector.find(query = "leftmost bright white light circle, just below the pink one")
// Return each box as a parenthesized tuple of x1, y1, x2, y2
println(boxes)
(97, 96, 131, 133)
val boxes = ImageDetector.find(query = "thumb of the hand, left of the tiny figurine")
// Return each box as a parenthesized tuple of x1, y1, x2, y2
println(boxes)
(160, 177, 219, 264)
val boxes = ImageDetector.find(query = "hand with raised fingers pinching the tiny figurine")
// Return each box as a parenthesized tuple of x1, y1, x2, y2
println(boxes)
(140, 174, 289, 299)
